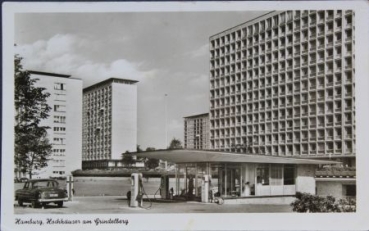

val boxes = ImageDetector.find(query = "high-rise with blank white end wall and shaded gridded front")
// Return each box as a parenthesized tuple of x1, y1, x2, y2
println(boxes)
(82, 78, 138, 169)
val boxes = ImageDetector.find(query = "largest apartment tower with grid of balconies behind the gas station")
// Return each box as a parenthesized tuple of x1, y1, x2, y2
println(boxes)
(210, 10, 355, 165)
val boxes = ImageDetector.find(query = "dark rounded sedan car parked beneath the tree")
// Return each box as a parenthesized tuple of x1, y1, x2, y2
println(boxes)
(15, 179, 68, 208)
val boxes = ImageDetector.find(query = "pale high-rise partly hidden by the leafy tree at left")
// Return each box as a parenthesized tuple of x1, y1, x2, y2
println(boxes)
(29, 71, 82, 178)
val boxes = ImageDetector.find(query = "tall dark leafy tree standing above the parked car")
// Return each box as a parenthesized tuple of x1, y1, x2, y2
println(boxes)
(14, 55, 52, 179)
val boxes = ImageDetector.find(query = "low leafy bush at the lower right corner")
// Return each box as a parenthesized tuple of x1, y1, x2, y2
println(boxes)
(291, 192, 356, 213)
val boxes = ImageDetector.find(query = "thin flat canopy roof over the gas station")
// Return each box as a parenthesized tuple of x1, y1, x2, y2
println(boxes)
(135, 149, 340, 164)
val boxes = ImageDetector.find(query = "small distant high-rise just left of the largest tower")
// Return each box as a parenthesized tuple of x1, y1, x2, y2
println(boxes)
(184, 113, 210, 149)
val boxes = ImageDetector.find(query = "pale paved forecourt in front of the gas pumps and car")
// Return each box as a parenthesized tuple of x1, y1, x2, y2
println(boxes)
(14, 196, 292, 214)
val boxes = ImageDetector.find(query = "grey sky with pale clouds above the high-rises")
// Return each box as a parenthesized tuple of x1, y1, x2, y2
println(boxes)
(14, 11, 267, 149)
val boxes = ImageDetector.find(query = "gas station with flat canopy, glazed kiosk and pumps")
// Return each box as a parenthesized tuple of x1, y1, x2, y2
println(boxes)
(131, 149, 340, 205)
